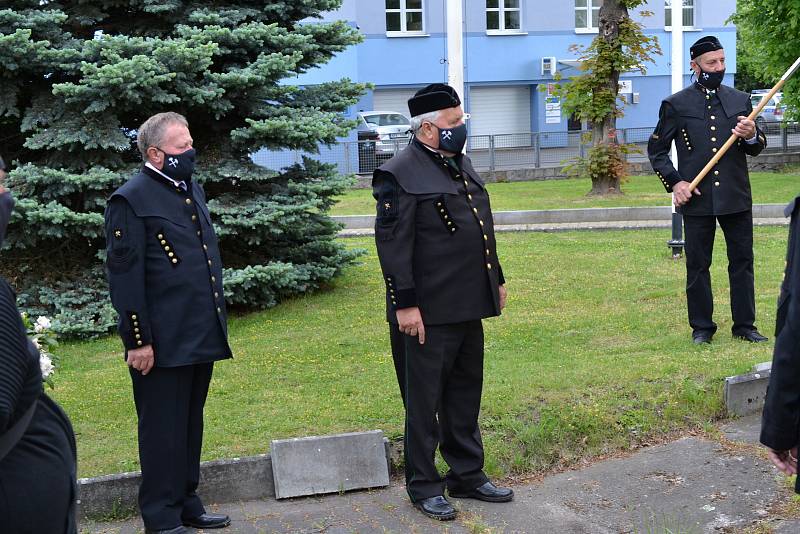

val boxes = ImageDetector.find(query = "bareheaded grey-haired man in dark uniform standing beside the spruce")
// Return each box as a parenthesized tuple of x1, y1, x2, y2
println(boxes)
(106, 113, 231, 533)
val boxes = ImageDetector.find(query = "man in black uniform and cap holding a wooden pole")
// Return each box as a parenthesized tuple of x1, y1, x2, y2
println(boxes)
(647, 36, 767, 343)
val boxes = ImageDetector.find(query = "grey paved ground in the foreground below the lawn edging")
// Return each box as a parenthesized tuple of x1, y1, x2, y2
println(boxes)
(80, 417, 800, 534)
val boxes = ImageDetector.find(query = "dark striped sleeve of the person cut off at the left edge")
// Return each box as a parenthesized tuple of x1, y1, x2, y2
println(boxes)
(0, 279, 30, 435)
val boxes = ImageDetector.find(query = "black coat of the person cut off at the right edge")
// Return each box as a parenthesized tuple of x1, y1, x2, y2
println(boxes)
(761, 197, 800, 460)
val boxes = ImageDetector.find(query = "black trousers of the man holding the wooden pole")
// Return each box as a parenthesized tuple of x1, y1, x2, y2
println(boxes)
(683, 210, 756, 334)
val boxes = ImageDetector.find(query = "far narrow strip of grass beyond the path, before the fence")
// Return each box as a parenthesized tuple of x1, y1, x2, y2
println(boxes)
(331, 172, 800, 215)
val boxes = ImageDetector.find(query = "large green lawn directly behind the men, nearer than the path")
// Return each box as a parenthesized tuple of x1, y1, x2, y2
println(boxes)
(51, 227, 787, 476)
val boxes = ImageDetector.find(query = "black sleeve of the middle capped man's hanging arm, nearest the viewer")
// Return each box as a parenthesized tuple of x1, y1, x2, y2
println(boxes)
(372, 171, 418, 310)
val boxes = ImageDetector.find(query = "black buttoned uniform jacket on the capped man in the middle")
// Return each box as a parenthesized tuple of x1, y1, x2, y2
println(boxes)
(372, 139, 505, 325)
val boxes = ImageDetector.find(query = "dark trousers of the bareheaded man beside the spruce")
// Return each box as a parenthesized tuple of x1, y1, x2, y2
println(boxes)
(130, 363, 214, 530)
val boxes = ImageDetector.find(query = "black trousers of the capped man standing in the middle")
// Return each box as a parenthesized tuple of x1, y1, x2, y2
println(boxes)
(390, 320, 488, 502)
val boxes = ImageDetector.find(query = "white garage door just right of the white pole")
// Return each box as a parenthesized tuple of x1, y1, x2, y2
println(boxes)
(467, 85, 531, 148)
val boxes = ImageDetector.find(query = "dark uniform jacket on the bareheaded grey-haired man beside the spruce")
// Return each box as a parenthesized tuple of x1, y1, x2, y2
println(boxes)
(106, 167, 231, 367)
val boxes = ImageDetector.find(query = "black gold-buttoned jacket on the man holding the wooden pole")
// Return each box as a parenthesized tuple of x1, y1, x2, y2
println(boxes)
(647, 83, 767, 215)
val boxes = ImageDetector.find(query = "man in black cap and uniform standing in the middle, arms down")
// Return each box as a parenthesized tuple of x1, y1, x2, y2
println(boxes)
(372, 84, 513, 520)
